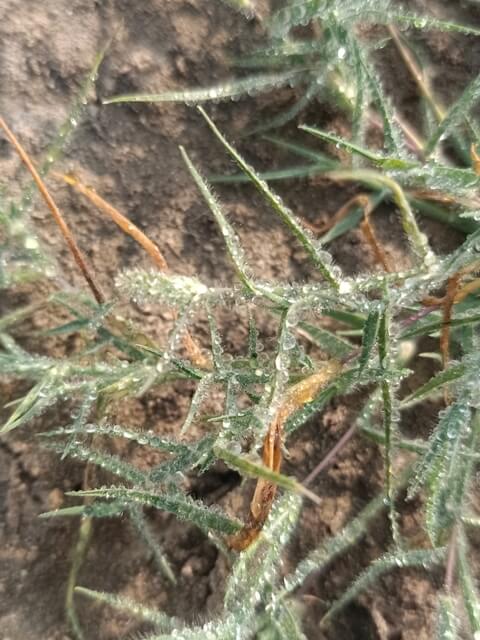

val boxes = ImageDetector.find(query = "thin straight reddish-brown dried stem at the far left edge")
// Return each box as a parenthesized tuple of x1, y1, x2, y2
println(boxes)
(0, 116, 105, 304)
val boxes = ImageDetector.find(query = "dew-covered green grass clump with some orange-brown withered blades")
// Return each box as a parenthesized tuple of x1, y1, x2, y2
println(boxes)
(0, 0, 480, 640)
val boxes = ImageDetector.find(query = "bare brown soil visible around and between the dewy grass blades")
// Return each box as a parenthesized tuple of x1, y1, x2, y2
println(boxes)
(0, 0, 480, 640)
